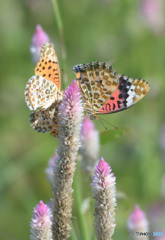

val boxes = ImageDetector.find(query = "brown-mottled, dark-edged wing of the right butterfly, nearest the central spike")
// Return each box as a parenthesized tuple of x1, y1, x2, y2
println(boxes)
(73, 62, 119, 115)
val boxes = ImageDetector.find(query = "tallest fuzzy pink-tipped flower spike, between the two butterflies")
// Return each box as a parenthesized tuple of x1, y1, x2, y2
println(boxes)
(52, 80, 83, 240)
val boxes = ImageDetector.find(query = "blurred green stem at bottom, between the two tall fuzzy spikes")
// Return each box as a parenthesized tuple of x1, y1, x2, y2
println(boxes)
(73, 165, 89, 239)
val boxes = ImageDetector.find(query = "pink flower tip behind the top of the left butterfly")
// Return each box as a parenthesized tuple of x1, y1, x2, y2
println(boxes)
(30, 25, 50, 63)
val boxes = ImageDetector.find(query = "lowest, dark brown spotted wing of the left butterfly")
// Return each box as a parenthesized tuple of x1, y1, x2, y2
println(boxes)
(30, 101, 60, 137)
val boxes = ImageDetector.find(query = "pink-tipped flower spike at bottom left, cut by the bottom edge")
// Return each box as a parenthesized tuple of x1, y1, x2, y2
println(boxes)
(30, 201, 52, 240)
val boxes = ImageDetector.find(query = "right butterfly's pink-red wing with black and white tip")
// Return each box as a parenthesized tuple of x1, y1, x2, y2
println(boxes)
(97, 75, 150, 114)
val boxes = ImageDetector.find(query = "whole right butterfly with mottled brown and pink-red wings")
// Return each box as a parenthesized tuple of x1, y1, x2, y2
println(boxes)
(73, 61, 150, 119)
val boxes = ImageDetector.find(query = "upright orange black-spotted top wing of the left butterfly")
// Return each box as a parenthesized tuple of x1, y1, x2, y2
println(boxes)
(35, 42, 61, 90)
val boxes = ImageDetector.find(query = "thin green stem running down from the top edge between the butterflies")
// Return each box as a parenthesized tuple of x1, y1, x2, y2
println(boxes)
(51, 0, 67, 88)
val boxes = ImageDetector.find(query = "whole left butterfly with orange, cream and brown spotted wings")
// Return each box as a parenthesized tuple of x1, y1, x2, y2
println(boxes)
(25, 42, 63, 137)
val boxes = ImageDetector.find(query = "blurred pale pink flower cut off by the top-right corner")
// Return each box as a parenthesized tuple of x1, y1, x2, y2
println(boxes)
(142, 0, 165, 33)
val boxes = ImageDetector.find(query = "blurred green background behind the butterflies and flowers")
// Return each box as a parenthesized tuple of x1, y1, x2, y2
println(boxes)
(0, 0, 165, 240)
